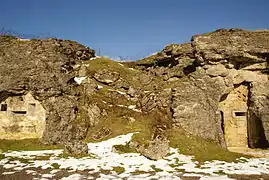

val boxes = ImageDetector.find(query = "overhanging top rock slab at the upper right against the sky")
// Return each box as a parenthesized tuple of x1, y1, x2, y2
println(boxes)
(192, 29, 269, 66)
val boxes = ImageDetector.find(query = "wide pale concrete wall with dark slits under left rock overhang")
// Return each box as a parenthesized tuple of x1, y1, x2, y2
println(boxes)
(0, 93, 46, 139)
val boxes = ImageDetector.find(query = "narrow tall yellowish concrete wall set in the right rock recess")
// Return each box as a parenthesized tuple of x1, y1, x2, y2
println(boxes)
(220, 85, 248, 147)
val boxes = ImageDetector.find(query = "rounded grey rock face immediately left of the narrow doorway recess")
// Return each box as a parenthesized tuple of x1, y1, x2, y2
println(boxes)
(171, 72, 233, 147)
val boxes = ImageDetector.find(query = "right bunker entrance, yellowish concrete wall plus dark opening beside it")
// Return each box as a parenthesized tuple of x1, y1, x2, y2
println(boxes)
(219, 83, 269, 148)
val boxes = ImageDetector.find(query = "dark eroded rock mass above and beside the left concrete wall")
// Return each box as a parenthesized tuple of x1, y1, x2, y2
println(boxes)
(0, 36, 94, 144)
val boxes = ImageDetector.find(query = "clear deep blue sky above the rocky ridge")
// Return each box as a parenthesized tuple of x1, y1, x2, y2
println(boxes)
(0, 0, 269, 60)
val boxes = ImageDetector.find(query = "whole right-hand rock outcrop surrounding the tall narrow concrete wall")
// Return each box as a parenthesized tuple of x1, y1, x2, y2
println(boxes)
(141, 29, 269, 147)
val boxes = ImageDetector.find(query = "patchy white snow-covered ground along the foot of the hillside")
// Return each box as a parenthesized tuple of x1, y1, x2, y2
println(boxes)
(0, 133, 269, 180)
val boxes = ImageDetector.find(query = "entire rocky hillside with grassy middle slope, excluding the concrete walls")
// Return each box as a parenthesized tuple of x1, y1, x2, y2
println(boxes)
(0, 29, 269, 159)
